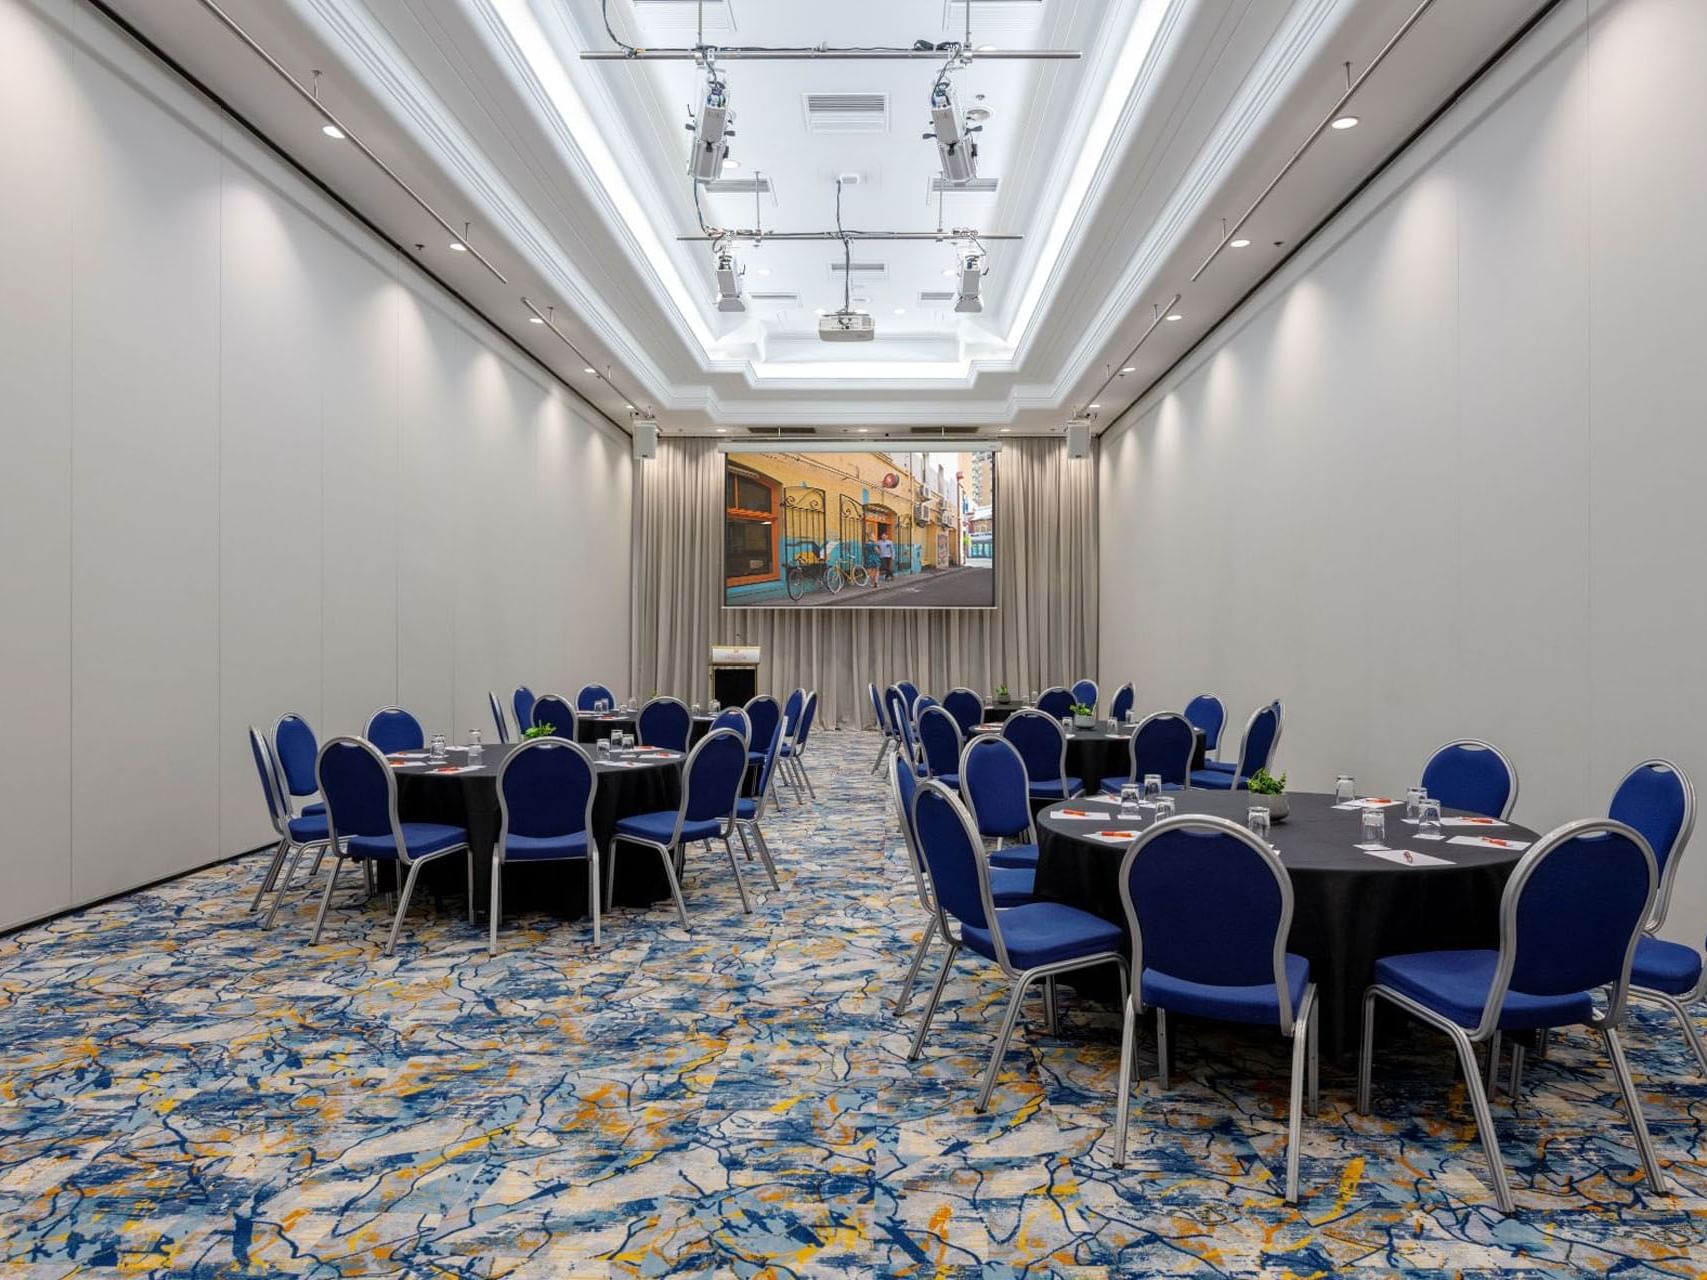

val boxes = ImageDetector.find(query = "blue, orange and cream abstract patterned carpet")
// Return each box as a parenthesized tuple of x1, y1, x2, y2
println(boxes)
(0, 732, 1707, 1278)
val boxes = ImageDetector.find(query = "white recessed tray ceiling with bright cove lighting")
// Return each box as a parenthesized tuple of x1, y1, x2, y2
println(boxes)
(106, 0, 1548, 433)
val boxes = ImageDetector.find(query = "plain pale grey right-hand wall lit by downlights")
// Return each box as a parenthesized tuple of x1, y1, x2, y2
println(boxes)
(1099, 0, 1707, 942)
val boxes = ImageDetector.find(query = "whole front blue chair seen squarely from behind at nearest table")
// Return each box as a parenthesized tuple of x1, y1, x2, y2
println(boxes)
(1115, 815, 1318, 1205)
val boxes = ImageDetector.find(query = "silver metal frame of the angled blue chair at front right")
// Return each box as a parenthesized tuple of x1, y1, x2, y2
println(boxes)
(1357, 817, 1669, 1215)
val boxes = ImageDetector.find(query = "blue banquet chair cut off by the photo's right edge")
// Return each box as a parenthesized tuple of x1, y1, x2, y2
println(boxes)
(1606, 759, 1707, 1075)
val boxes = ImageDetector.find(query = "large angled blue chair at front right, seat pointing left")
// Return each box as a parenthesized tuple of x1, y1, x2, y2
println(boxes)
(1357, 819, 1668, 1213)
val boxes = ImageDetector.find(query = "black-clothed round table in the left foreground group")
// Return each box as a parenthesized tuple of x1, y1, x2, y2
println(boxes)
(393, 742, 683, 920)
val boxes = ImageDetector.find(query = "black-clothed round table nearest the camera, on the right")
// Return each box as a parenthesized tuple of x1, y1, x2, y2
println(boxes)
(1034, 790, 1536, 1058)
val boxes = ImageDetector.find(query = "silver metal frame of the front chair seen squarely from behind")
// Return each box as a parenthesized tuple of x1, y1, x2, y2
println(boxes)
(1115, 815, 1321, 1205)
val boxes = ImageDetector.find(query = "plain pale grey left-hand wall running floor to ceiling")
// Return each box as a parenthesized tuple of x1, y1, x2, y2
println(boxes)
(0, 0, 630, 927)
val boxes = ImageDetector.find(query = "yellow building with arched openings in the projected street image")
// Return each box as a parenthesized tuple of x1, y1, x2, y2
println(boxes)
(724, 452, 988, 604)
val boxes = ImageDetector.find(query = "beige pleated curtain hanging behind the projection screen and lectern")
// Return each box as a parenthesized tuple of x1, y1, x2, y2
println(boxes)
(630, 439, 1098, 725)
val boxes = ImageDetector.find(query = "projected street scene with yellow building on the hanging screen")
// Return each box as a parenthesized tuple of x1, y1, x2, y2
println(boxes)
(724, 449, 995, 609)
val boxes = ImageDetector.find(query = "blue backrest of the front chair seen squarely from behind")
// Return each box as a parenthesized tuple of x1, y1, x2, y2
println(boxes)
(1120, 816, 1292, 1031)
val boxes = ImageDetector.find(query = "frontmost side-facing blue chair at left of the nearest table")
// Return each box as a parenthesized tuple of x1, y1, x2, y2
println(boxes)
(908, 780, 1127, 1111)
